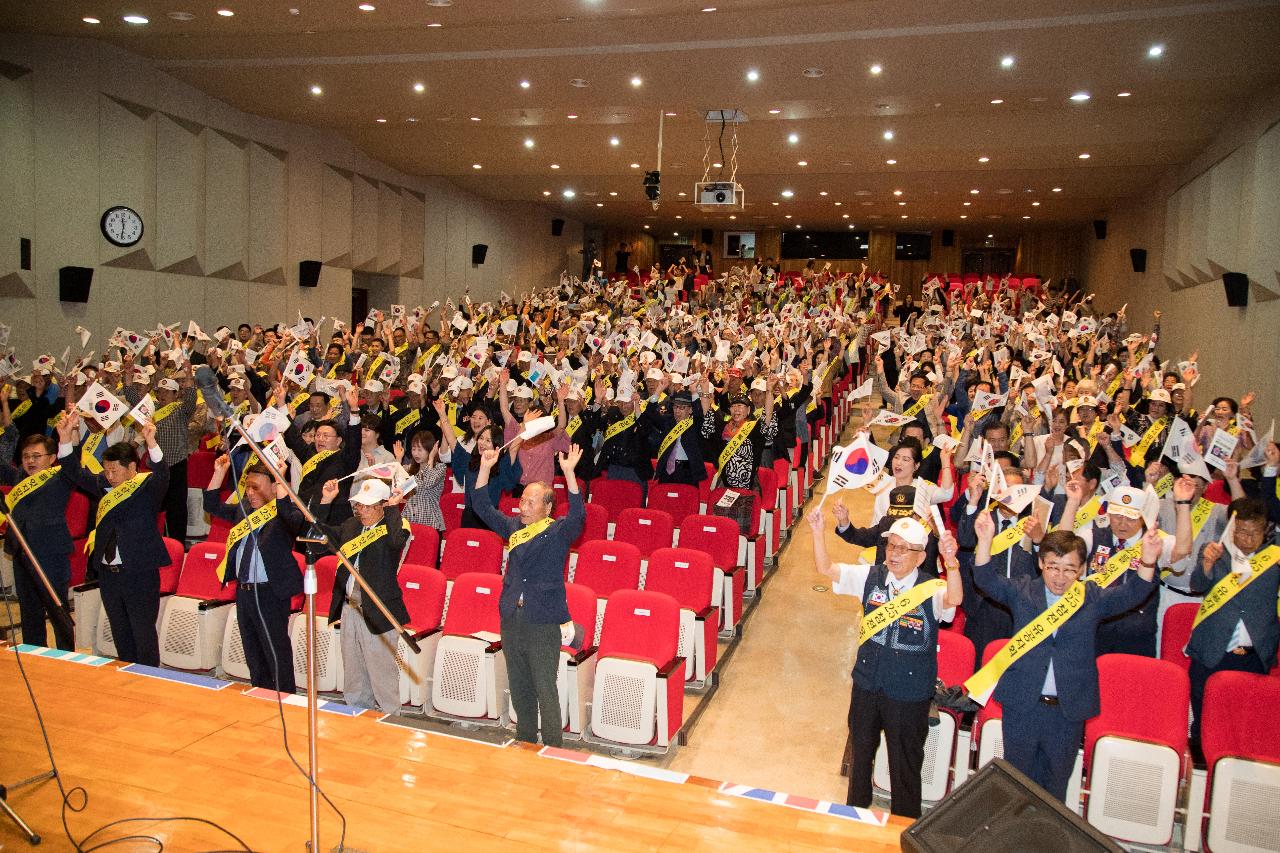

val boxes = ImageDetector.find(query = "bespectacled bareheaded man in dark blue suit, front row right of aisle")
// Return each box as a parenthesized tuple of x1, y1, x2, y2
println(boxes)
(973, 511, 1162, 799)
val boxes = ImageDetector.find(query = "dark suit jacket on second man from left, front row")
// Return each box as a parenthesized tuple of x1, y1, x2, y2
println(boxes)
(73, 448, 169, 573)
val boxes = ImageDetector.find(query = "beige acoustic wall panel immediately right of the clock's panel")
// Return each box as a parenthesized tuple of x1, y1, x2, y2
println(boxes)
(152, 113, 205, 275)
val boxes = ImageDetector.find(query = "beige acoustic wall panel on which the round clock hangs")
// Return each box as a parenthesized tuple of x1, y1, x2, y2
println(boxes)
(97, 95, 156, 270)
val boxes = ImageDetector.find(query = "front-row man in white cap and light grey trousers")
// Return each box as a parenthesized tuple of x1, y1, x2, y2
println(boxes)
(317, 480, 410, 715)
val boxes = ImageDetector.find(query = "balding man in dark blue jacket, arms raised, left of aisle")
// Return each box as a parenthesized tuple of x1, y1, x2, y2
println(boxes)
(467, 444, 586, 747)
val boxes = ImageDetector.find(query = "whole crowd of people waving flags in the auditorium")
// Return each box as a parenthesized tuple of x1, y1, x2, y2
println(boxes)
(0, 263, 1280, 816)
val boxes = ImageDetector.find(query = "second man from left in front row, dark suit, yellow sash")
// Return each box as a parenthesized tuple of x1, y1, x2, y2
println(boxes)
(70, 421, 169, 666)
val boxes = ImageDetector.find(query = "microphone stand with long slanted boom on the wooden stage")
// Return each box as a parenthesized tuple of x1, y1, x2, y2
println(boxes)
(216, 404, 421, 853)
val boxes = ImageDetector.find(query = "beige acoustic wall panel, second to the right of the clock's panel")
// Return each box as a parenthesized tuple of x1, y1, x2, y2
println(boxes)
(205, 128, 250, 280)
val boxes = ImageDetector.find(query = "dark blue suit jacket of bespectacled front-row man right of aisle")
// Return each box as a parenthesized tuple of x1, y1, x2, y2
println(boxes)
(973, 562, 1156, 721)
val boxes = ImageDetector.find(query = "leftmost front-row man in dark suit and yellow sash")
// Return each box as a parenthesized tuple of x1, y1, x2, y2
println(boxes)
(0, 415, 79, 651)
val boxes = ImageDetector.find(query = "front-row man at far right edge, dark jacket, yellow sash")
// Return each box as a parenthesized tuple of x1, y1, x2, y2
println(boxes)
(1187, 498, 1280, 743)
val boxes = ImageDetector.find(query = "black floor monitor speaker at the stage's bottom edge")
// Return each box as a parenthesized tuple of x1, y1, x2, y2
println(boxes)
(900, 758, 1123, 853)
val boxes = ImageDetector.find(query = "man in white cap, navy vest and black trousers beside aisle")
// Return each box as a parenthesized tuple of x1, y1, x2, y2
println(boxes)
(809, 510, 964, 817)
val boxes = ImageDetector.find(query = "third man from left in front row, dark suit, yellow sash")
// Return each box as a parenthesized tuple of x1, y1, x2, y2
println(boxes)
(205, 455, 305, 693)
